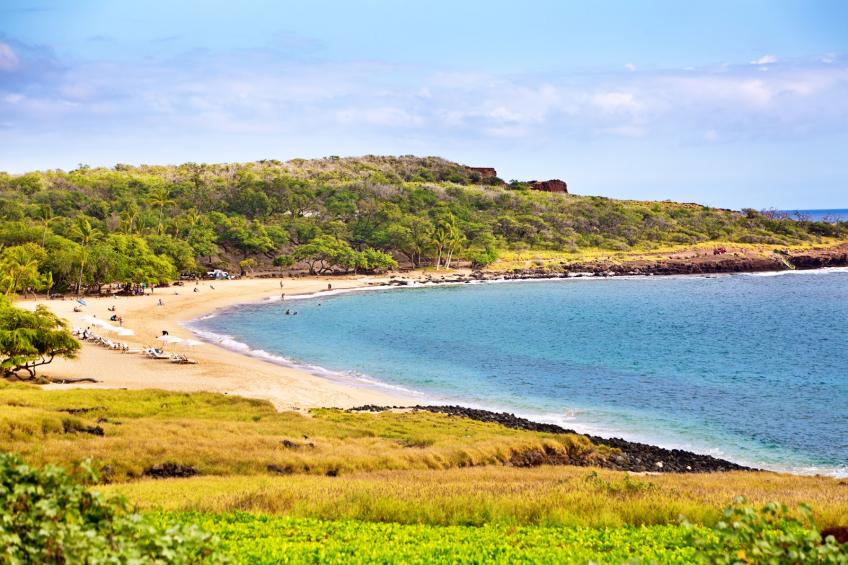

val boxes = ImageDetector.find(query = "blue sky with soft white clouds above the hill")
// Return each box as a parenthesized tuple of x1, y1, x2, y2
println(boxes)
(0, 0, 848, 209)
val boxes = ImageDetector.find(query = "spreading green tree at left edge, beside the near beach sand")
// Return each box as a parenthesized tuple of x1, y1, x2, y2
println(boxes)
(0, 297, 80, 378)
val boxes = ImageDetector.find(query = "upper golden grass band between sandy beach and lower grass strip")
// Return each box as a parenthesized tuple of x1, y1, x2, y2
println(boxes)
(0, 386, 610, 481)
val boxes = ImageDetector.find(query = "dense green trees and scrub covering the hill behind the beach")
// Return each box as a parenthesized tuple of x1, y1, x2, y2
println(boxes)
(0, 156, 848, 294)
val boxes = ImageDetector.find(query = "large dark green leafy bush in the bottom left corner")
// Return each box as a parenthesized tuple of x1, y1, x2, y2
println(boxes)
(0, 454, 222, 563)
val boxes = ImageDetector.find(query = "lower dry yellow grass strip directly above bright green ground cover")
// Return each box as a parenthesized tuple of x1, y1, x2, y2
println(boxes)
(103, 466, 848, 527)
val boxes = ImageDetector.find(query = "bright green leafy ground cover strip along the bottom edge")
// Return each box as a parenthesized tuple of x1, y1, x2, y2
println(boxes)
(152, 513, 708, 564)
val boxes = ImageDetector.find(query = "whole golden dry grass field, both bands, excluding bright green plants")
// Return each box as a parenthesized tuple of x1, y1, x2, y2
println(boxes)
(6, 378, 848, 527)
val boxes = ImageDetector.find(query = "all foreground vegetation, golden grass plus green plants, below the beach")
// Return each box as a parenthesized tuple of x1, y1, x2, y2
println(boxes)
(0, 383, 848, 563)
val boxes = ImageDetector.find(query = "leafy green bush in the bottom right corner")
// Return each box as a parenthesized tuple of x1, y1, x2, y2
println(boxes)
(693, 497, 848, 565)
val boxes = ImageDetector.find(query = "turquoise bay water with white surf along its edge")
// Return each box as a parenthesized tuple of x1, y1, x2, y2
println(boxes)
(194, 269, 848, 475)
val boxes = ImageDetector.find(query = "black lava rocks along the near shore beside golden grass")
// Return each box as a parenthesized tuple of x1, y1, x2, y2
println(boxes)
(350, 405, 752, 473)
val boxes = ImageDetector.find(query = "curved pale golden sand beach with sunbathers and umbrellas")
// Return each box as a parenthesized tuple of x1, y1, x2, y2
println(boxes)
(17, 277, 418, 410)
